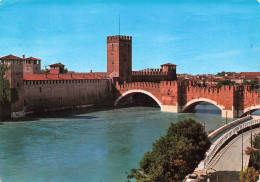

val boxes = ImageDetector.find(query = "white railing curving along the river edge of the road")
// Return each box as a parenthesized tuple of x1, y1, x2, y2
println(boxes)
(204, 119, 260, 168)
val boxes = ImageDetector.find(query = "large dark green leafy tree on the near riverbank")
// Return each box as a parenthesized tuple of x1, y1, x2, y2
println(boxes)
(128, 119, 210, 182)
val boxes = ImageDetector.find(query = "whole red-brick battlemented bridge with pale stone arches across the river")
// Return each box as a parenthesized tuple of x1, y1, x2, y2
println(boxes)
(114, 81, 260, 118)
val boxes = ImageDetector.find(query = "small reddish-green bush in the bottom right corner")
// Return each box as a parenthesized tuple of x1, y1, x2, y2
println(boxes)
(239, 167, 259, 182)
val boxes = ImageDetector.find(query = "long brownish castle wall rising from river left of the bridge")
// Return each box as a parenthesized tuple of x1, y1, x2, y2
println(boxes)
(24, 80, 111, 112)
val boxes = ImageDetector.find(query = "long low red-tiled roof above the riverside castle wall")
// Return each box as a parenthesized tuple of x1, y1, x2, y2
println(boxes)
(23, 74, 102, 81)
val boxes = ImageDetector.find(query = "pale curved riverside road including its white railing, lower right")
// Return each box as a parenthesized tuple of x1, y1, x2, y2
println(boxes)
(195, 116, 260, 181)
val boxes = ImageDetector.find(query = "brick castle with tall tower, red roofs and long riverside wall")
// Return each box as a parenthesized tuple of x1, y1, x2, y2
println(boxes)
(0, 35, 177, 117)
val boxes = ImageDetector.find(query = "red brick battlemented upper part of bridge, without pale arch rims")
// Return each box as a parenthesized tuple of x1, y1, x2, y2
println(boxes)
(116, 81, 260, 110)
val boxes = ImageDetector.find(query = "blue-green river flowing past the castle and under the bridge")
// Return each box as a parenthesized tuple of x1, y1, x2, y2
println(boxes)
(0, 105, 254, 182)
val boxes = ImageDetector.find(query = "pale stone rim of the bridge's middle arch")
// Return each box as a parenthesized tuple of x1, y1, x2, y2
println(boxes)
(182, 98, 224, 112)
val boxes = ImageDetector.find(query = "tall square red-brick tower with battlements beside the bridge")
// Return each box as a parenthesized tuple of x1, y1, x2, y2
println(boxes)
(107, 35, 132, 83)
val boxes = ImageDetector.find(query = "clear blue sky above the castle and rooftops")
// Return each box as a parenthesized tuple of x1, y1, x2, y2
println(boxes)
(0, 0, 260, 74)
